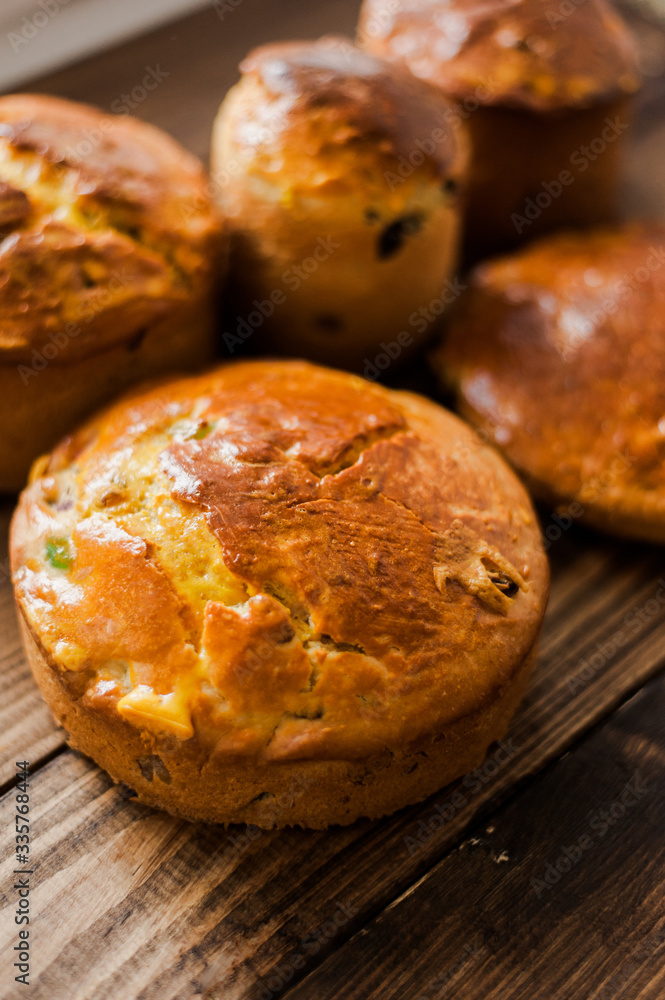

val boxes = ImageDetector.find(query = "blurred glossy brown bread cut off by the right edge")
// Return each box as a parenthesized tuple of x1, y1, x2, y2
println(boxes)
(435, 225, 665, 542)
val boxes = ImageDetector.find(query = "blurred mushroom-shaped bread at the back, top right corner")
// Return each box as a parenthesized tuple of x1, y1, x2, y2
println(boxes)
(358, 0, 639, 259)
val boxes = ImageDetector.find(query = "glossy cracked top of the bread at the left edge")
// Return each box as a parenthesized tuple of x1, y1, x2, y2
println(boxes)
(0, 95, 222, 364)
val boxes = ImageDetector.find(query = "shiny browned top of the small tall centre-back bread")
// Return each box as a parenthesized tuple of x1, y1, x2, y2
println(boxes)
(214, 36, 464, 207)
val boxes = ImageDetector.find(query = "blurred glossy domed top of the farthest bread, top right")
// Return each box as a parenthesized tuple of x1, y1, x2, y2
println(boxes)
(358, 0, 639, 111)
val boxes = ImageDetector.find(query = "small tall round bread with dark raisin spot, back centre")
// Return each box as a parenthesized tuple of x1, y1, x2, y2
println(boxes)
(212, 37, 466, 378)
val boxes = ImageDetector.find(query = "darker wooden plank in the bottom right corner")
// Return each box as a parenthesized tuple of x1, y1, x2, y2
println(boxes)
(282, 679, 665, 1000)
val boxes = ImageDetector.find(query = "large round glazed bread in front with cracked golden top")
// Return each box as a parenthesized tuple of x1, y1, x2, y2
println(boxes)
(11, 361, 548, 828)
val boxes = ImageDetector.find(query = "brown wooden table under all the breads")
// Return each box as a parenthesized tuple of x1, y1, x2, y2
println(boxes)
(0, 0, 665, 1000)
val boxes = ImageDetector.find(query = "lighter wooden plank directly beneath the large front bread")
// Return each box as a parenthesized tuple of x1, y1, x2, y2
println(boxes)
(0, 529, 665, 1000)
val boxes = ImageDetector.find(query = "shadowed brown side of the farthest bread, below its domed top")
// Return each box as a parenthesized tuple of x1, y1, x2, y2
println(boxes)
(454, 98, 633, 262)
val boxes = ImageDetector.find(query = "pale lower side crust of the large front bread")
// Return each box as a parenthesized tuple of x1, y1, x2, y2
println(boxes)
(19, 608, 535, 830)
